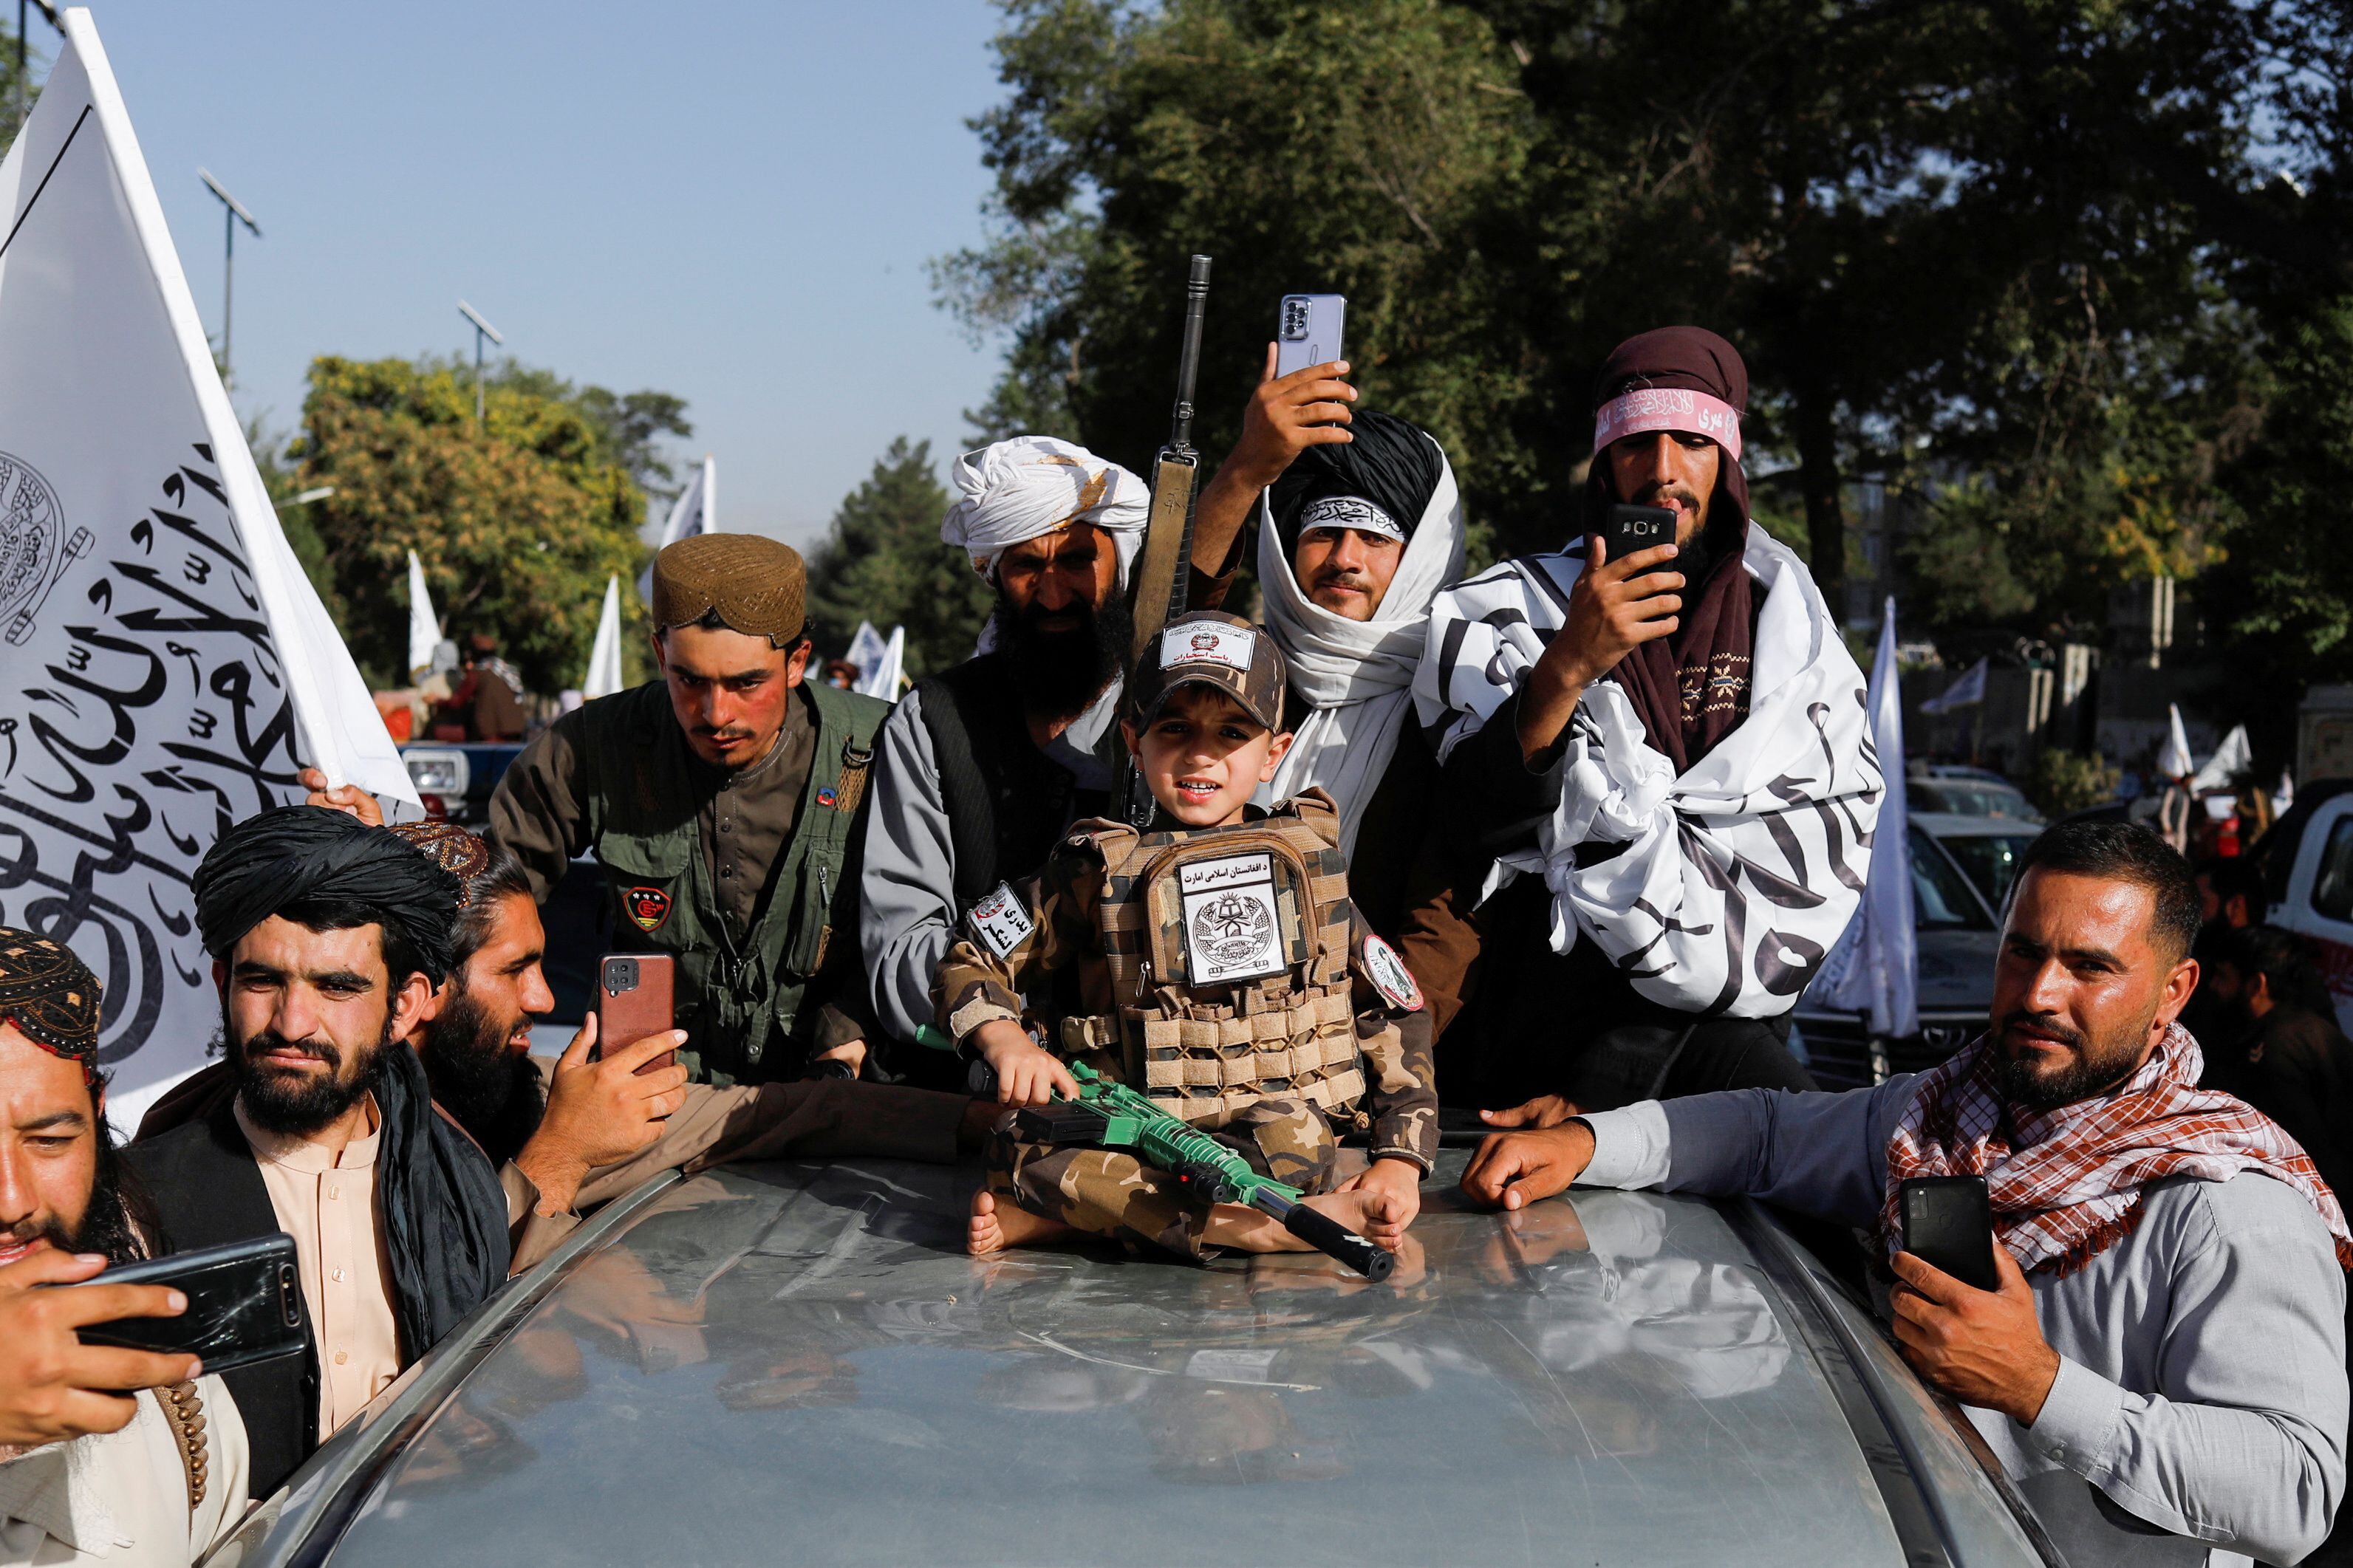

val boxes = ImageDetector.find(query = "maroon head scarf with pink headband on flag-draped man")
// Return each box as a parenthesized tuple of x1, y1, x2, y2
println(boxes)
(1586, 326, 1755, 773)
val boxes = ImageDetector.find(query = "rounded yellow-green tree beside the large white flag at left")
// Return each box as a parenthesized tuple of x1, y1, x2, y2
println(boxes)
(287, 355, 663, 691)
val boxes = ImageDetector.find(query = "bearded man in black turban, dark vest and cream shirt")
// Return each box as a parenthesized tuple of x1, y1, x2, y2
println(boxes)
(125, 807, 513, 1495)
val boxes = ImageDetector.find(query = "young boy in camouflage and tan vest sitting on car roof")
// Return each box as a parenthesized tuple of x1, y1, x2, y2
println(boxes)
(934, 614, 1438, 1258)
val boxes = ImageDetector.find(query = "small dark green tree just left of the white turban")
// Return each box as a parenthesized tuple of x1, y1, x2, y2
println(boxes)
(810, 435, 993, 679)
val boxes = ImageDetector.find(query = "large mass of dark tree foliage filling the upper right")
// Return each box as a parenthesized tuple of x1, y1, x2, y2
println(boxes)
(939, 0, 2353, 634)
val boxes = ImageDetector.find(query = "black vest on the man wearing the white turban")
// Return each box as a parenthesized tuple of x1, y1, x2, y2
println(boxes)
(915, 654, 1108, 910)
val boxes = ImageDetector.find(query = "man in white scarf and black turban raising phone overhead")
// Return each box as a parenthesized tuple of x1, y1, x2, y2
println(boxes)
(1200, 383, 1464, 938)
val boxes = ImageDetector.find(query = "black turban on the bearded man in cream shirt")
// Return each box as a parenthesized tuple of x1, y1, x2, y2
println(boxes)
(195, 807, 463, 985)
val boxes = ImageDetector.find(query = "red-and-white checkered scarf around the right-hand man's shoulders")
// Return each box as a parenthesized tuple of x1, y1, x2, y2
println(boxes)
(1880, 1023, 2353, 1276)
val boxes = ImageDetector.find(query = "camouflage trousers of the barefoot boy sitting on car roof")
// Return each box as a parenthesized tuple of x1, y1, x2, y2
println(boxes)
(981, 1100, 1339, 1258)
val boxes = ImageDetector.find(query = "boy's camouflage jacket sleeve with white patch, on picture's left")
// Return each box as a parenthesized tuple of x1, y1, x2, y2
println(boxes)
(932, 837, 1104, 1044)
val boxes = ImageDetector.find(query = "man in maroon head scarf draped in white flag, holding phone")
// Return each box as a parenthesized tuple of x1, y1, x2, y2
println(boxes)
(1398, 326, 1882, 1121)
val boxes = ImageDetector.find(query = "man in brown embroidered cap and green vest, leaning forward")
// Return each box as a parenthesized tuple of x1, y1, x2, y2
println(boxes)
(487, 534, 885, 1083)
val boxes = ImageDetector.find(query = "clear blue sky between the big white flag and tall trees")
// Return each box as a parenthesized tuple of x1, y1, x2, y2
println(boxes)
(52, 0, 1000, 543)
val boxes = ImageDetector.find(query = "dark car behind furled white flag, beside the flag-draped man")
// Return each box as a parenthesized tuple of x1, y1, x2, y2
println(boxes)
(1793, 811, 2004, 1089)
